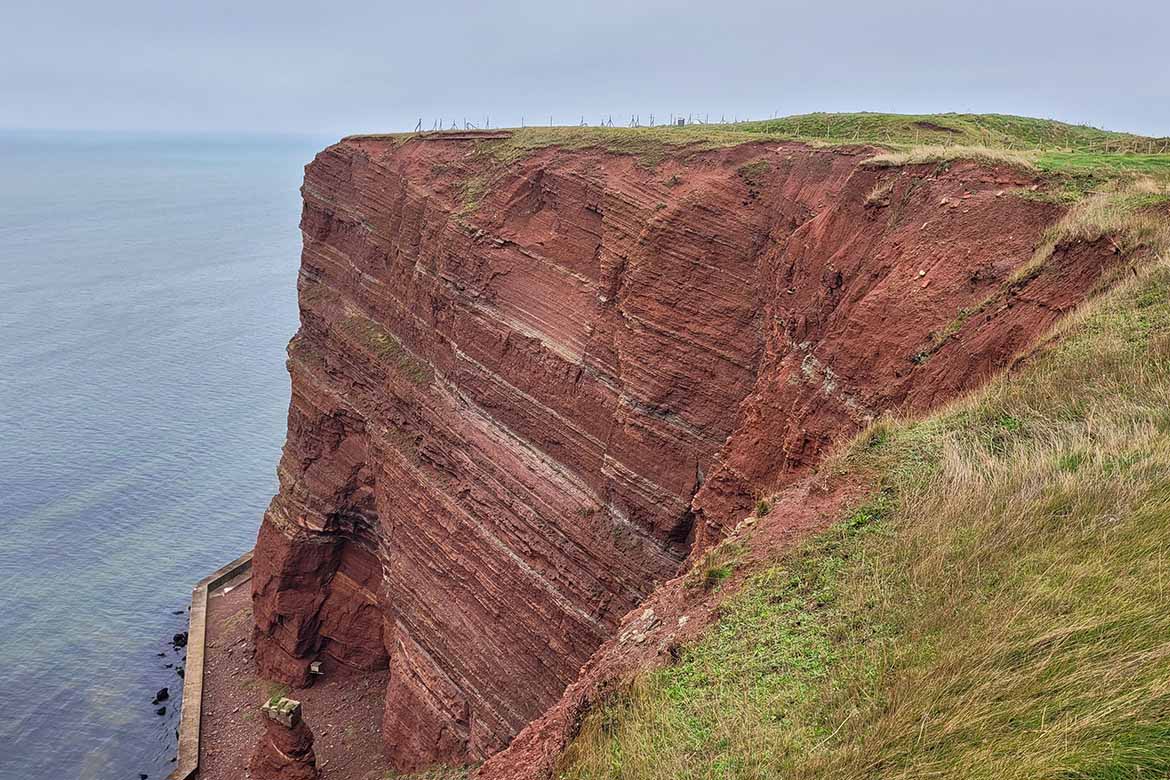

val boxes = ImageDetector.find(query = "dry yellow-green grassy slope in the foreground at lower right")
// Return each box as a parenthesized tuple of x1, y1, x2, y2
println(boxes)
(558, 244, 1170, 780)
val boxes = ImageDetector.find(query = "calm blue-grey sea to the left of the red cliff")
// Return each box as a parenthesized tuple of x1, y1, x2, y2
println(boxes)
(0, 133, 325, 780)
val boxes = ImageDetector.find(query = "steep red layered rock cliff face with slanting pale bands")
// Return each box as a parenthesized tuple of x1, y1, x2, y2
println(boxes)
(253, 136, 1109, 769)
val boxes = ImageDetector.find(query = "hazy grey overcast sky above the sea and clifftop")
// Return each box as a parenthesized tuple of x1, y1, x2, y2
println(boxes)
(0, 0, 1170, 136)
